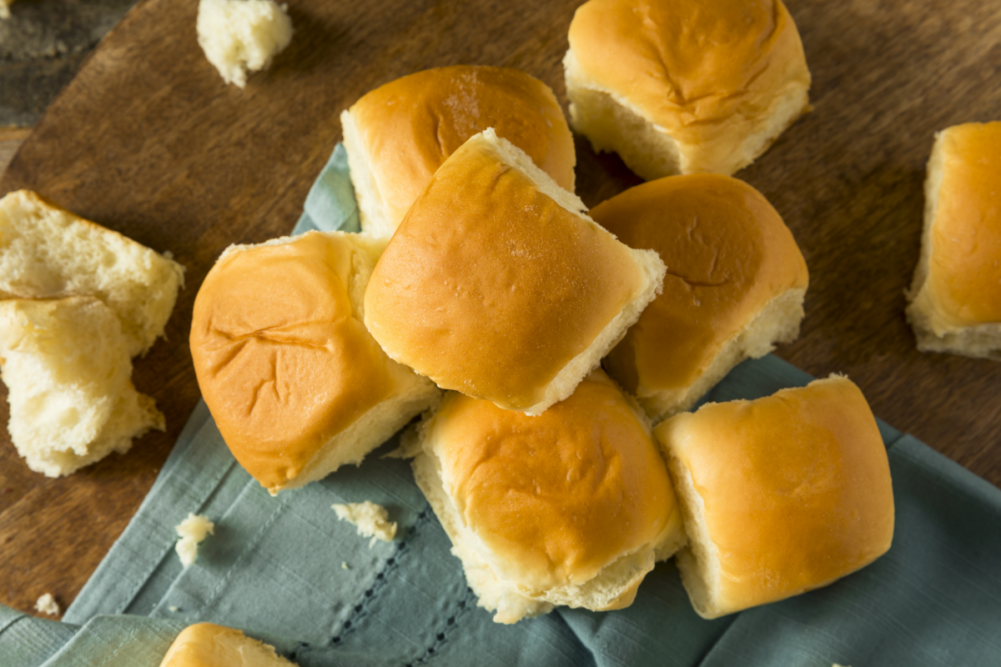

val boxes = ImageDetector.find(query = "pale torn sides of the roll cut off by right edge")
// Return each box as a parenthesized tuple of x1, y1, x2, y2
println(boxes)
(906, 123, 1001, 361)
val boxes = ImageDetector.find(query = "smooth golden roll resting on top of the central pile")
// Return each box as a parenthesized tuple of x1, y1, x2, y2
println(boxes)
(365, 130, 664, 414)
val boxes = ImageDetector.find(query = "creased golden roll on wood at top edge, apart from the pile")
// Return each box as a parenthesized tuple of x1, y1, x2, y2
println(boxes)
(564, 0, 810, 180)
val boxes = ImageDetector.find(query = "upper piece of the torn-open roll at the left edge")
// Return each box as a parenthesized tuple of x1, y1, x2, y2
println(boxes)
(0, 190, 184, 357)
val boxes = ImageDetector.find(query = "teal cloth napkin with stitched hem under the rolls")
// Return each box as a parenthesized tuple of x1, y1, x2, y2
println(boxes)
(0, 145, 1001, 667)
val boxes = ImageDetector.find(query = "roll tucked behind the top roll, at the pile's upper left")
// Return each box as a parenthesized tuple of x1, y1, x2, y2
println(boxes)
(341, 65, 577, 238)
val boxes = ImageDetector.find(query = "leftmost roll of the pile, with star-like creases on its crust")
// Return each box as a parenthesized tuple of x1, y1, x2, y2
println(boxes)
(191, 232, 437, 494)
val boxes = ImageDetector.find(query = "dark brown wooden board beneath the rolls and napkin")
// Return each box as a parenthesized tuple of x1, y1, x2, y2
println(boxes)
(0, 0, 1001, 611)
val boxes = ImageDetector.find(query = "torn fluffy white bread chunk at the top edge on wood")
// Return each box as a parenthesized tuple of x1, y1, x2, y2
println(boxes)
(197, 0, 292, 88)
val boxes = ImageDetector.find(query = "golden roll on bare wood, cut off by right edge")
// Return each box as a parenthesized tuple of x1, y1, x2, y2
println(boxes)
(907, 122, 1001, 360)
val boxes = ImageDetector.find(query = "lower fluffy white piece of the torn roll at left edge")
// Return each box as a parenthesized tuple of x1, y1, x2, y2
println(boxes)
(0, 296, 164, 477)
